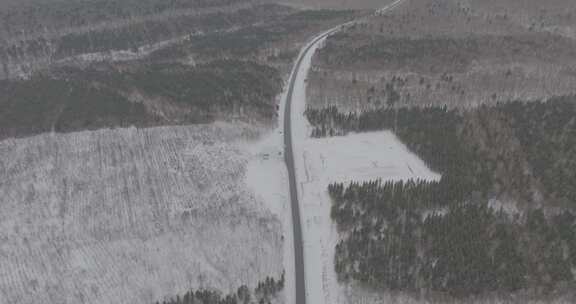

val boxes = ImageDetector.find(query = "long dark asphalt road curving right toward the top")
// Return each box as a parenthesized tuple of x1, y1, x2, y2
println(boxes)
(284, 0, 405, 304)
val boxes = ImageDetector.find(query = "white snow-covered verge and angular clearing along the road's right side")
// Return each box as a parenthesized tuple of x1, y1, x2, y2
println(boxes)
(291, 15, 440, 304)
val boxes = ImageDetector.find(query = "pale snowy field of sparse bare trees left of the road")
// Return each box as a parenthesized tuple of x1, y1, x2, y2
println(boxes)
(0, 123, 284, 304)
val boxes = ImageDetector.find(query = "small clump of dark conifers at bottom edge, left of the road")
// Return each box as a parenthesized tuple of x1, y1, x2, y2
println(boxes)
(156, 274, 284, 304)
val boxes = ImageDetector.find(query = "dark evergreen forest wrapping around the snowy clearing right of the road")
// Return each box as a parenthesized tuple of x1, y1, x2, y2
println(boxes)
(306, 96, 576, 297)
